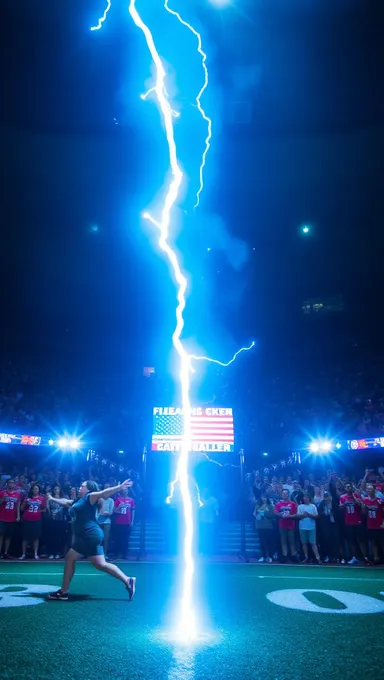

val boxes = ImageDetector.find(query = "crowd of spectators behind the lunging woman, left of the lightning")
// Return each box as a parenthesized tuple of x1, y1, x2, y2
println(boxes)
(0, 467, 142, 560)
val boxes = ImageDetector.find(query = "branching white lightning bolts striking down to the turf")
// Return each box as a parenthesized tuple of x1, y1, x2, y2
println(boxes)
(91, 0, 254, 642)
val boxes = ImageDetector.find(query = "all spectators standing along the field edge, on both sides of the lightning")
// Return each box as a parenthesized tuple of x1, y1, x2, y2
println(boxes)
(0, 462, 384, 565)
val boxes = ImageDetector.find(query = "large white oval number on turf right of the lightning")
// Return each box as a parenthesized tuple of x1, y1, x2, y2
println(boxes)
(267, 588, 384, 614)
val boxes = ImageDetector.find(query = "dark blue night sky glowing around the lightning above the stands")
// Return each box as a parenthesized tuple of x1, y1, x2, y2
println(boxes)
(0, 0, 384, 378)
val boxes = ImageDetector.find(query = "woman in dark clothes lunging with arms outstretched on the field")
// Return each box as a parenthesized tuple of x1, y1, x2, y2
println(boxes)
(47, 480, 136, 600)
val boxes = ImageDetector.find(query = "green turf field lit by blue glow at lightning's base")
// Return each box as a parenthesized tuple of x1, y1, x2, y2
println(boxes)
(0, 562, 384, 680)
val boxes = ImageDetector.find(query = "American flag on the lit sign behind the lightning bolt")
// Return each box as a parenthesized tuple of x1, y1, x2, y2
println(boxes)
(152, 411, 234, 445)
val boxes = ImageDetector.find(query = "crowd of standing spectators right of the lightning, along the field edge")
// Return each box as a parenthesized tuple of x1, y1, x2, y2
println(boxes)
(251, 467, 384, 565)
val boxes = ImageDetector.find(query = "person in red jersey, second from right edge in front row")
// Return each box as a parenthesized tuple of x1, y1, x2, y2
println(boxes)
(340, 482, 368, 564)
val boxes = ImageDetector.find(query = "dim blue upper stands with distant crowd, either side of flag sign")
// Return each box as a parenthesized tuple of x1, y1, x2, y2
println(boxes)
(0, 356, 384, 451)
